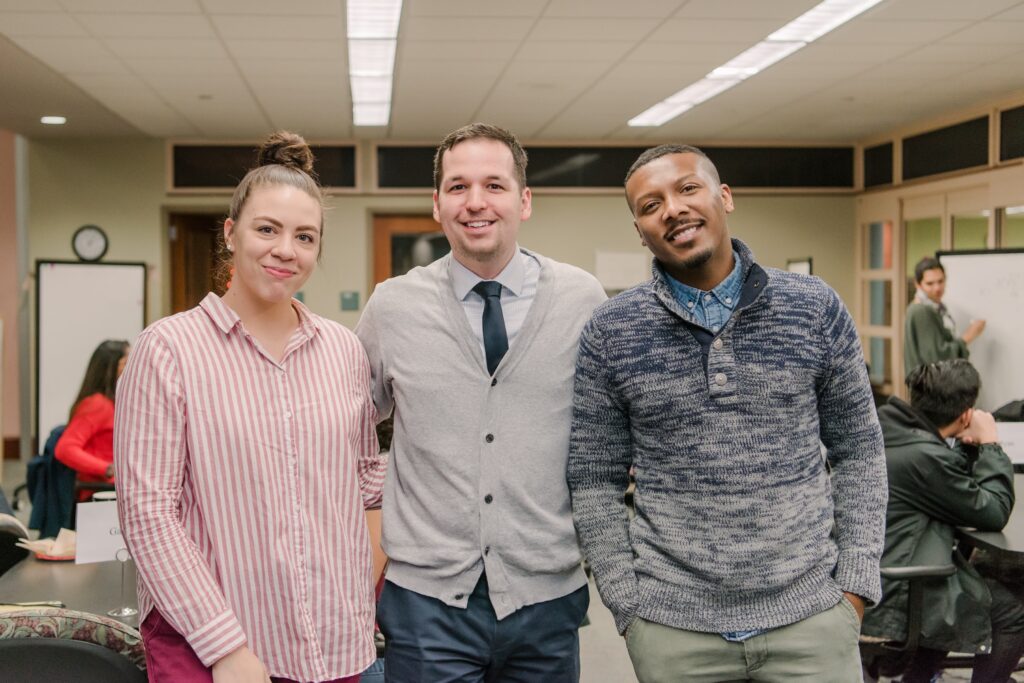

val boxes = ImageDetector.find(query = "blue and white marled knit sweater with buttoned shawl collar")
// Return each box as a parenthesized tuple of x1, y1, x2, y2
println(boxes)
(568, 240, 887, 633)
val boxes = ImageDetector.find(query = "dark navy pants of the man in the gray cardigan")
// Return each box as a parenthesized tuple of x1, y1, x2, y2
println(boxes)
(377, 575, 590, 683)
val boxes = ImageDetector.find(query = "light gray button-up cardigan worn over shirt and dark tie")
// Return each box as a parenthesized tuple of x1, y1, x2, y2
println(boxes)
(355, 252, 605, 618)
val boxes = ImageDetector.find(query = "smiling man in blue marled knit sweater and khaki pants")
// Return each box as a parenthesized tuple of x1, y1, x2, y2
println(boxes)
(568, 145, 886, 683)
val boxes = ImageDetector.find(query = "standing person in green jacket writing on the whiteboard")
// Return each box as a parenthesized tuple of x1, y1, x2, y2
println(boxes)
(903, 257, 985, 373)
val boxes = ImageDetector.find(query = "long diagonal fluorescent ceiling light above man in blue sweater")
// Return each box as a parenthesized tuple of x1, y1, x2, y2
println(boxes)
(628, 0, 882, 127)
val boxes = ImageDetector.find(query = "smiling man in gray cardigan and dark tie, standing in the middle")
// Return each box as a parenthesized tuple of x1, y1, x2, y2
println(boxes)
(355, 124, 605, 683)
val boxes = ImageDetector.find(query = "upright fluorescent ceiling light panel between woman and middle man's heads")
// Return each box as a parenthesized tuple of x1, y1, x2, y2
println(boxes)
(346, 0, 401, 126)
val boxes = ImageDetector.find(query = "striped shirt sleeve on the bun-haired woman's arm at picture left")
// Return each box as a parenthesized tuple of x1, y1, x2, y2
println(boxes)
(114, 328, 246, 667)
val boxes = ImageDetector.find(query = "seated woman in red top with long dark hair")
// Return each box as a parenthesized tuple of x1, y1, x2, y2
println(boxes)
(54, 339, 129, 493)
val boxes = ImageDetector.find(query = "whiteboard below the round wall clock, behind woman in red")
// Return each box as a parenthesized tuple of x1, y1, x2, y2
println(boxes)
(36, 261, 145, 445)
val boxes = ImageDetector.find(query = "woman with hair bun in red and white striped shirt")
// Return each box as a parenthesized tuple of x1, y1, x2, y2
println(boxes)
(115, 132, 386, 683)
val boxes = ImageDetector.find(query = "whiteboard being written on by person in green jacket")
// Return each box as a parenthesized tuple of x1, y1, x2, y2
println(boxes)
(938, 250, 1024, 411)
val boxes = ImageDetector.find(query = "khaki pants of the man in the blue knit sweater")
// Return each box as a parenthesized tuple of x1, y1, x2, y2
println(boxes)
(626, 598, 863, 683)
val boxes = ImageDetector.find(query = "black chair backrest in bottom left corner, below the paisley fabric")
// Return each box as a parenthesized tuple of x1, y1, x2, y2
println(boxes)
(0, 638, 145, 683)
